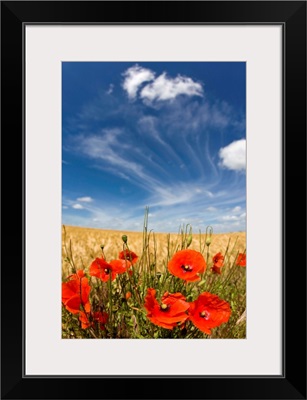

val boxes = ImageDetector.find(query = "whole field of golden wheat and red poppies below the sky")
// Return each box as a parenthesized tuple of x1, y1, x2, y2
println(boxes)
(62, 213, 246, 339)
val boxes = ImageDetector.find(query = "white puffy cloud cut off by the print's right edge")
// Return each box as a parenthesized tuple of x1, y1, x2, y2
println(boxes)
(219, 139, 246, 171)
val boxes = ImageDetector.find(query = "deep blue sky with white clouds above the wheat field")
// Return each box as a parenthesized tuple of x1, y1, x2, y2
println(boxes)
(62, 61, 246, 233)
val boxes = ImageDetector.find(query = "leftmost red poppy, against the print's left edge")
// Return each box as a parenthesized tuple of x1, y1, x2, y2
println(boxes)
(62, 270, 91, 314)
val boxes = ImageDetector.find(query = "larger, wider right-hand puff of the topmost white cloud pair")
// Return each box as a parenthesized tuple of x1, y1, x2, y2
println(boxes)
(140, 73, 203, 102)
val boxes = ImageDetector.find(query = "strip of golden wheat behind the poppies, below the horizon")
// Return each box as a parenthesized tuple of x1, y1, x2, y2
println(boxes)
(62, 226, 246, 276)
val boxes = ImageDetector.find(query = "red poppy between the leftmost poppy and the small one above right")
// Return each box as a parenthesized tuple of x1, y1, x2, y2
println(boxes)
(90, 258, 131, 282)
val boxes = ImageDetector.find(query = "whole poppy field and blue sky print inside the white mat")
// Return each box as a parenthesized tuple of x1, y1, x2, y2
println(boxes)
(59, 60, 247, 339)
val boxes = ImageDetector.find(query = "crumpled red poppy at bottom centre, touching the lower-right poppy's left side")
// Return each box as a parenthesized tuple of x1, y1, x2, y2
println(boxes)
(144, 288, 189, 329)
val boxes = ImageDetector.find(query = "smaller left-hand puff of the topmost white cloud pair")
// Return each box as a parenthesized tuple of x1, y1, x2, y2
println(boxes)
(123, 65, 155, 99)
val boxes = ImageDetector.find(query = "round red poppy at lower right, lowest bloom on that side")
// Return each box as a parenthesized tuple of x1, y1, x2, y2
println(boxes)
(189, 292, 231, 335)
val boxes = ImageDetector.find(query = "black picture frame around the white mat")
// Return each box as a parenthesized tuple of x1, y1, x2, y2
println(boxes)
(1, 1, 306, 399)
